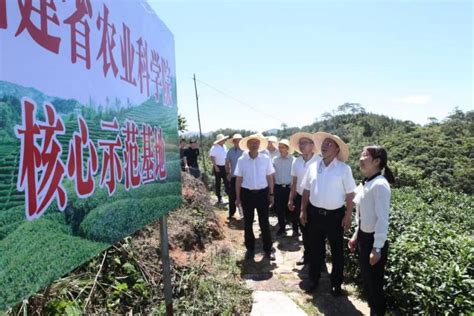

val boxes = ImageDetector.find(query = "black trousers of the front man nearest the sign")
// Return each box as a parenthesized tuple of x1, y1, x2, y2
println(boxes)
(240, 188, 272, 252)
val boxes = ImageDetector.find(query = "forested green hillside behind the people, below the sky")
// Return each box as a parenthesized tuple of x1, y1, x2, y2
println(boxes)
(202, 103, 474, 194)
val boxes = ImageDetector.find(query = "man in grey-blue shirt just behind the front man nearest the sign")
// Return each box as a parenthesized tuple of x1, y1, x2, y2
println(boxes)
(272, 139, 298, 237)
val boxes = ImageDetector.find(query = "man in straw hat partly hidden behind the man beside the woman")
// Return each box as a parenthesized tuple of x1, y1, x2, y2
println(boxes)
(288, 132, 324, 265)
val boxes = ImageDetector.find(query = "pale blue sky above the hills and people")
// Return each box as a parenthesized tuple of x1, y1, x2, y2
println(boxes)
(149, 0, 473, 131)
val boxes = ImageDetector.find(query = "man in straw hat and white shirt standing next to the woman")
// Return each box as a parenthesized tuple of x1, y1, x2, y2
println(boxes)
(301, 132, 356, 296)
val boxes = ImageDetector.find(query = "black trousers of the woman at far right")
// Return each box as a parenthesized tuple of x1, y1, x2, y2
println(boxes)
(357, 230, 388, 315)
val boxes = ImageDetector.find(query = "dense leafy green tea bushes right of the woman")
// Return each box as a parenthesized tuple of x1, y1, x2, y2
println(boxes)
(347, 184, 474, 315)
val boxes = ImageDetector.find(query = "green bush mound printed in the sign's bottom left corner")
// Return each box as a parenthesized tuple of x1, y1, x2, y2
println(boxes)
(0, 218, 107, 310)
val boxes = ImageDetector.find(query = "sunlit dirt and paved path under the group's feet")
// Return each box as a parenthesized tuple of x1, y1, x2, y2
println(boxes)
(211, 201, 369, 315)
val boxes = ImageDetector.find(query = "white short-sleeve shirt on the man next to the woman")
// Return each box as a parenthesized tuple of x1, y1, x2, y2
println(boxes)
(303, 159, 356, 210)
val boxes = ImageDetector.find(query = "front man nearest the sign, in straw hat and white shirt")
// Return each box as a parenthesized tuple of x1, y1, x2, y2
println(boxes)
(235, 135, 275, 260)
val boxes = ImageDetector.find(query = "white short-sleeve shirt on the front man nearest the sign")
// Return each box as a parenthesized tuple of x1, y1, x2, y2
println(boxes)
(234, 153, 275, 190)
